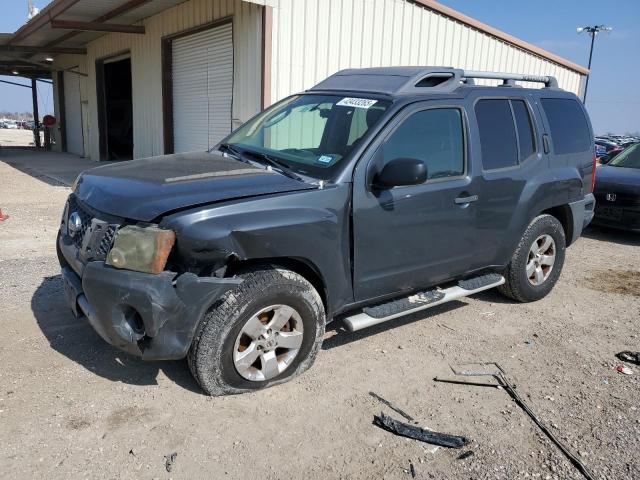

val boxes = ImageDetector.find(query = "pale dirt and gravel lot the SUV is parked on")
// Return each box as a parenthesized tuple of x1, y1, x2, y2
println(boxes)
(0, 153, 640, 480)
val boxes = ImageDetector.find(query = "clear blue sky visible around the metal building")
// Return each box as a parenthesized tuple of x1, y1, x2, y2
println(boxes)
(0, 0, 640, 133)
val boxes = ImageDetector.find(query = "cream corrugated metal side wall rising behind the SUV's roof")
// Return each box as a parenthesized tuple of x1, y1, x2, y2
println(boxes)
(271, 0, 581, 101)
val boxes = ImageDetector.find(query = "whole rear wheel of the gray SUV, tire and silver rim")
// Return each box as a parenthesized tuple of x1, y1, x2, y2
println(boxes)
(498, 215, 566, 302)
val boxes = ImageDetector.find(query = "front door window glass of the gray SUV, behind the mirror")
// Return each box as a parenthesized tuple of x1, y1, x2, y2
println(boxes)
(382, 108, 464, 179)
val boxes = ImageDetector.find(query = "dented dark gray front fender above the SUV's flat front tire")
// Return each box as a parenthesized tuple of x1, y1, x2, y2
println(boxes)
(161, 184, 353, 312)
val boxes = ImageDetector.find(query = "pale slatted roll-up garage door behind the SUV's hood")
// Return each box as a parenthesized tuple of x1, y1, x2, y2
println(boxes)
(172, 23, 233, 153)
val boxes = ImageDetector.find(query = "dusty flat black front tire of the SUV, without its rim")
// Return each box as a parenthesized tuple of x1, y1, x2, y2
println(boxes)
(187, 265, 326, 396)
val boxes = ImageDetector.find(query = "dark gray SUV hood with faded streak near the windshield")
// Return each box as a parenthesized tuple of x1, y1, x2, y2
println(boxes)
(75, 152, 317, 222)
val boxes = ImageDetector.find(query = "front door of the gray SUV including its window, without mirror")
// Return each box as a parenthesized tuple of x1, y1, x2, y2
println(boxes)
(353, 101, 476, 301)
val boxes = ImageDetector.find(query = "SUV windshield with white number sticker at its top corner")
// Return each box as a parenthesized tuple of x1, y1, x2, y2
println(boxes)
(222, 95, 391, 179)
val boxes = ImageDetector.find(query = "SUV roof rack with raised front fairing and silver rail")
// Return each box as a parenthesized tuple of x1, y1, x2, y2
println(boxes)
(311, 67, 558, 95)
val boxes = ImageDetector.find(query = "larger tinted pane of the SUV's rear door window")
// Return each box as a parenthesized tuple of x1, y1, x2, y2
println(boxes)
(475, 99, 518, 170)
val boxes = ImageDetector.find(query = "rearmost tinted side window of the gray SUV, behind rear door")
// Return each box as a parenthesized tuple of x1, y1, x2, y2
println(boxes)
(541, 98, 593, 155)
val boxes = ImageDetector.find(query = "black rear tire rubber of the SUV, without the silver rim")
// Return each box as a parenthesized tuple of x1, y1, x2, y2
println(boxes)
(498, 215, 567, 303)
